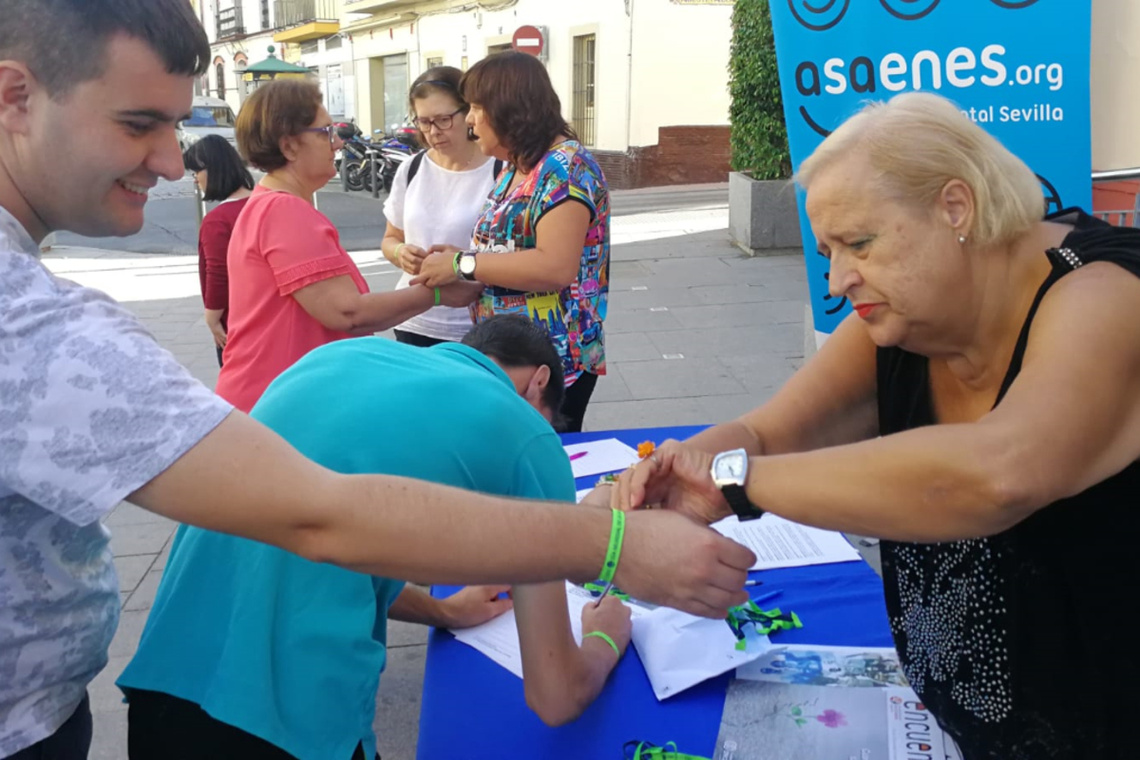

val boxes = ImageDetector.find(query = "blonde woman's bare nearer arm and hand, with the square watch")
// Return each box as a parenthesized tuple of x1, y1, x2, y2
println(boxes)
(628, 263, 1140, 541)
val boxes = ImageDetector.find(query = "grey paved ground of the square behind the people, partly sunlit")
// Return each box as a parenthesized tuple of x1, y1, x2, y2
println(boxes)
(44, 201, 880, 760)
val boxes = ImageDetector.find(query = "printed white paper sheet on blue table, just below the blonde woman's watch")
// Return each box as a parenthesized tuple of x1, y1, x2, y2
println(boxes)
(713, 514, 861, 570)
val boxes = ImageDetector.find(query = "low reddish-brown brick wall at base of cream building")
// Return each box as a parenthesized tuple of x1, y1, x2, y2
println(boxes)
(593, 126, 731, 190)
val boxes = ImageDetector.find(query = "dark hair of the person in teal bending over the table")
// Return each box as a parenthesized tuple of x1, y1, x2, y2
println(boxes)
(463, 314, 565, 426)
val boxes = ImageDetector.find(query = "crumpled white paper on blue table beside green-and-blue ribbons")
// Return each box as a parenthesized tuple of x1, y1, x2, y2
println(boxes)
(633, 607, 771, 700)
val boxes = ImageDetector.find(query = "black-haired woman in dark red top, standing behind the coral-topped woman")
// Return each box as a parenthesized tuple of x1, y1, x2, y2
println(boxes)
(182, 134, 253, 367)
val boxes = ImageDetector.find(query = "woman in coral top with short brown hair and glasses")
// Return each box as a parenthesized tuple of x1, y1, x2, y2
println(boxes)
(217, 80, 479, 411)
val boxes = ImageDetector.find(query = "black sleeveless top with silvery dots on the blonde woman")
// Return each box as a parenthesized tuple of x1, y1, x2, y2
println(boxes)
(878, 209, 1140, 760)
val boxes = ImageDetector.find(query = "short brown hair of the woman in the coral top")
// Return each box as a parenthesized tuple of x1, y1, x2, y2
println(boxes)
(234, 79, 324, 172)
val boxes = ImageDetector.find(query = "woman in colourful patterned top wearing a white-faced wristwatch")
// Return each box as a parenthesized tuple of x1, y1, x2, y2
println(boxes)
(413, 52, 610, 432)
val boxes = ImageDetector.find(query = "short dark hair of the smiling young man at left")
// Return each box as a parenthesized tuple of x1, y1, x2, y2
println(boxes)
(0, 0, 210, 98)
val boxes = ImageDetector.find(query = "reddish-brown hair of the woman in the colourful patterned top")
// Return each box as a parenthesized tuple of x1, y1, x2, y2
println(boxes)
(459, 50, 578, 171)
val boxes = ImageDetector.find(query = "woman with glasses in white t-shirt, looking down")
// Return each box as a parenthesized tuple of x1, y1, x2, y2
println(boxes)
(381, 66, 502, 346)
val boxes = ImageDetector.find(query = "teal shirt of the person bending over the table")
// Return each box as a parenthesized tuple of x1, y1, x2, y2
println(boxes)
(117, 337, 575, 760)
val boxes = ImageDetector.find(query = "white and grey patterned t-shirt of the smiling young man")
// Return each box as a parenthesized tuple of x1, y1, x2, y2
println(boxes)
(0, 207, 231, 758)
